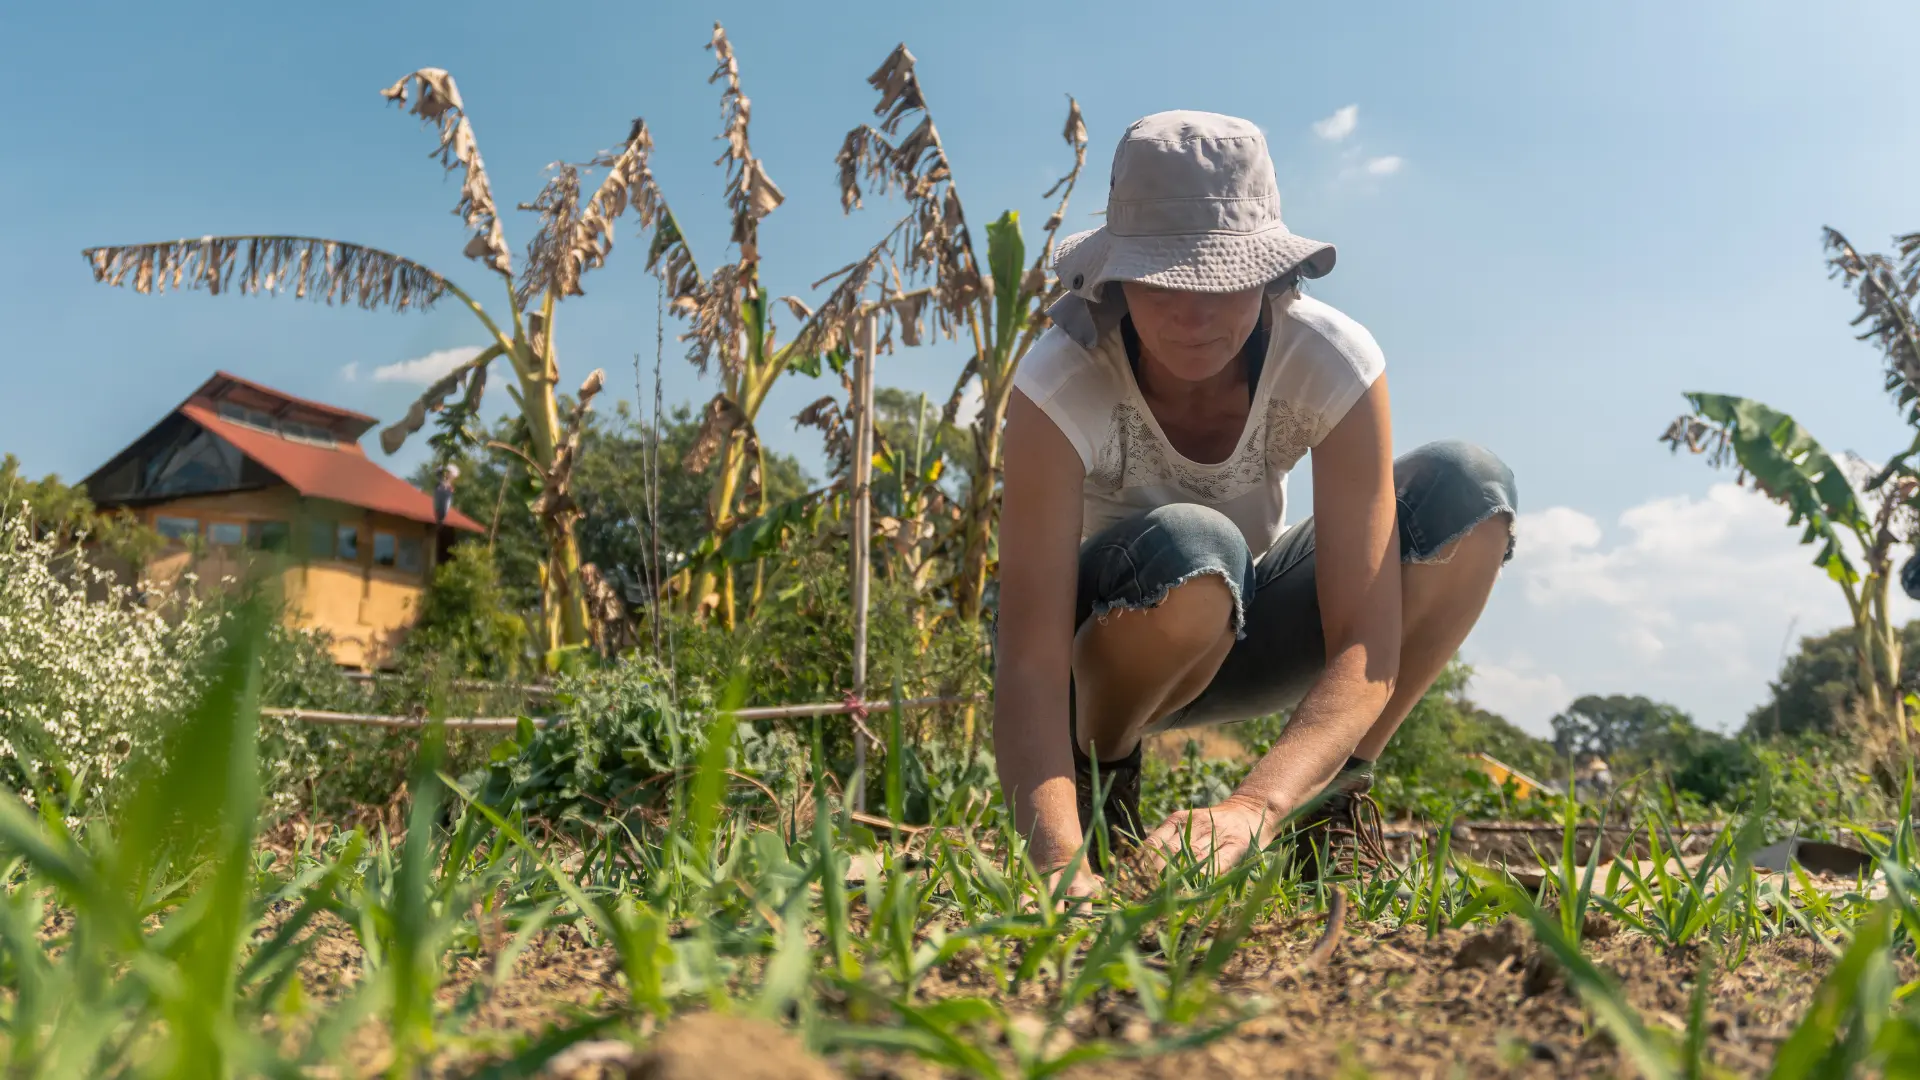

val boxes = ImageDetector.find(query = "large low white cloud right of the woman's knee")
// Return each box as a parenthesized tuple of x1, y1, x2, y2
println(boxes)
(1463, 484, 1916, 732)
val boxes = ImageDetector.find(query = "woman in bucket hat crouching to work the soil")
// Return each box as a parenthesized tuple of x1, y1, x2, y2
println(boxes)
(995, 111, 1515, 894)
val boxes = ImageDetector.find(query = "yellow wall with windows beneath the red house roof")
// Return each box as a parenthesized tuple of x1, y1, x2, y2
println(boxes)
(140, 486, 434, 667)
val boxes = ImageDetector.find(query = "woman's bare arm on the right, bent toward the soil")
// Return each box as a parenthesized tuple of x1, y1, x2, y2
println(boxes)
(1235, 375, 1400, 814)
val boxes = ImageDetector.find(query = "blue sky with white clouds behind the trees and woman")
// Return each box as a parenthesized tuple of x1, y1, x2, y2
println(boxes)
(0, 0, 1920, 728)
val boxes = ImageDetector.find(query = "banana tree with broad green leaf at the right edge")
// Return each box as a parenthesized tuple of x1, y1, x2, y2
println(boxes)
(1661, 229, 1920, 760)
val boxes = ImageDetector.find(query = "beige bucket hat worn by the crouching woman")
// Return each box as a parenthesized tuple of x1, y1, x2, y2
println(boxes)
(1050, 110, 1334, 338)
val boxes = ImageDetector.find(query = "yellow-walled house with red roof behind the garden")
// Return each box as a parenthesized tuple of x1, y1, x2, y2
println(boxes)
(83, 371, 484, 669)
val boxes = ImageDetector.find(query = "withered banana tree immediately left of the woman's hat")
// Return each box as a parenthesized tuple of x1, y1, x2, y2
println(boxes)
(837, 44, 1087, 619)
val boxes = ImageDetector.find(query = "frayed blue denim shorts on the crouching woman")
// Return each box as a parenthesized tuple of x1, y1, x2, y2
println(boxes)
(1073, 442, 1517, 730)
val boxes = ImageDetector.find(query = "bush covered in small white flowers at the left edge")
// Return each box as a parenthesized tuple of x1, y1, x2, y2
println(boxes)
(0, 513, 219, 809)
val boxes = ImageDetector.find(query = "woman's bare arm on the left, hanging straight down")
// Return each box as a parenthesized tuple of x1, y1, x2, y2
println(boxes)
(993, 390, 1085, 869)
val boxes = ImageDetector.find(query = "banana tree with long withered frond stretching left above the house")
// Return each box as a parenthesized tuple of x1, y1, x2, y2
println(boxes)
(84, 67, 691, 657)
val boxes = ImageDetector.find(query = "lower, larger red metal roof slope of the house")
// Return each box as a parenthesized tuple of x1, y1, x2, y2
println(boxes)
(180, 399, 486, 532)
